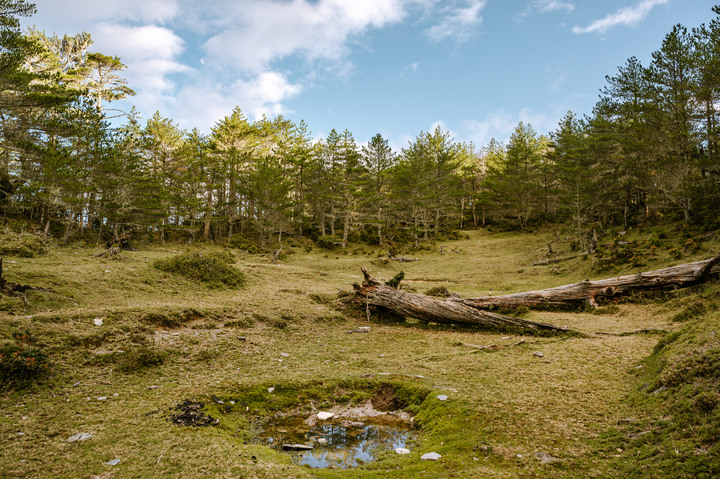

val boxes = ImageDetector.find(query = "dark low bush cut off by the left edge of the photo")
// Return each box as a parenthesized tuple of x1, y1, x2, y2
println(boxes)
(0, 344, 50, 390)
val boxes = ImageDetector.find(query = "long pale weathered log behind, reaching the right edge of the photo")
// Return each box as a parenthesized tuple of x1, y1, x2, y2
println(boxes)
(456, 255, 720, 310)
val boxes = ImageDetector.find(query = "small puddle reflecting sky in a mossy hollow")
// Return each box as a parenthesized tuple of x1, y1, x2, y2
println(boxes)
(256, 416, 417, 469)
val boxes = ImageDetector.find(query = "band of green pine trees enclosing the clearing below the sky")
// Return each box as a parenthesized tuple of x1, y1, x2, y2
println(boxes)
(0, 0, 720, 250)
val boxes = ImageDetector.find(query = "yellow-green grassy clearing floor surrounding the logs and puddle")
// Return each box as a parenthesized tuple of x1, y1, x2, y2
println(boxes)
(0, 230, 720, 478)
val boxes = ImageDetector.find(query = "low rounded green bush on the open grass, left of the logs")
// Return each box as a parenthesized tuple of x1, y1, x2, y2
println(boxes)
(153, 251, 245, 287)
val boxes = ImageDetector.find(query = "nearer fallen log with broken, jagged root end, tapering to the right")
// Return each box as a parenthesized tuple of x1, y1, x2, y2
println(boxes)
(354, 268, 570, 332)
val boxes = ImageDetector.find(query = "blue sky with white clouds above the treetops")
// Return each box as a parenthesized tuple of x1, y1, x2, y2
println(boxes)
(16, 0, 720, 151)
